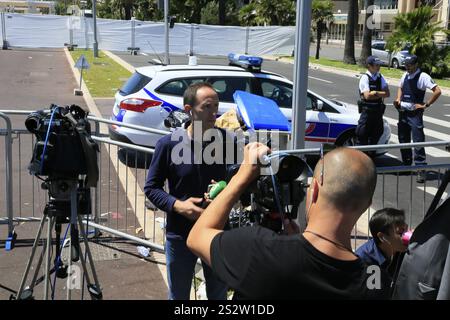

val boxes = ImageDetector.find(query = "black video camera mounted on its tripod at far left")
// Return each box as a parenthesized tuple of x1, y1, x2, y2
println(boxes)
(11, 104, 102, 300)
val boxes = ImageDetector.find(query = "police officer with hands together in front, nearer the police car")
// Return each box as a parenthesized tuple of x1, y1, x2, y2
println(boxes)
(356, 56, 390, 149)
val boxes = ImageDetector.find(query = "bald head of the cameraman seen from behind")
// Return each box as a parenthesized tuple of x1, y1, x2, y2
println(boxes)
(314, 148, 377, 213)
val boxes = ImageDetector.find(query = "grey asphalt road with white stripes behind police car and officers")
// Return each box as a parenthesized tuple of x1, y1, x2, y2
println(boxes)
(114, 52, 450, 228)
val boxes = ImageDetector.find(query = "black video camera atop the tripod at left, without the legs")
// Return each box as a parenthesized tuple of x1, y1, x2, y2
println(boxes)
(25, 104, 99, 217)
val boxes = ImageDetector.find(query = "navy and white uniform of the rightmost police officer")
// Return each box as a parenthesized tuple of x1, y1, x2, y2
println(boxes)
(398, 65, 436, 165)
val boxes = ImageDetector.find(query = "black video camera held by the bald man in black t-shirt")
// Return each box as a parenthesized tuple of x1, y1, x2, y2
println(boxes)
(227, 154, 311, 233)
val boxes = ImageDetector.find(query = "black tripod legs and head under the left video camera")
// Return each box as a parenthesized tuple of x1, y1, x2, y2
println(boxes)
(15, 179, 103, 300)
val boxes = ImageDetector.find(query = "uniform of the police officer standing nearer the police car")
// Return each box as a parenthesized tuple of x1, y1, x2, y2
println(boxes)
(355, 71, 388, 145)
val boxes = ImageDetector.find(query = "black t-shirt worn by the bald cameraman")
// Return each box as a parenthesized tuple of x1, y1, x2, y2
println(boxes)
(211, 227, 389, 299)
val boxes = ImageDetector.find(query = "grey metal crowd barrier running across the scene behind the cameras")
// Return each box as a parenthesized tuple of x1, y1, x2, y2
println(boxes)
(0, 110, 450, 252)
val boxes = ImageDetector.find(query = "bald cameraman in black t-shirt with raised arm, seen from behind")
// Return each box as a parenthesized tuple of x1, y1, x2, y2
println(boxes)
(187, 143, 388, 299)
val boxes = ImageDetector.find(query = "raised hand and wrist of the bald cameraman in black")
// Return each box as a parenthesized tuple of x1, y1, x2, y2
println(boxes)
(236, 142, 270, 182)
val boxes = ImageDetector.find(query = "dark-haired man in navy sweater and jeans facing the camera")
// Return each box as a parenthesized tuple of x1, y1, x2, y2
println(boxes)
(144, 82, 234, 300)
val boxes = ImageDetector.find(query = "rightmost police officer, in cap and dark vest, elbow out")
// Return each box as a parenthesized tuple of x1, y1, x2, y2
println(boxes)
(394, 55, 441, 183)
